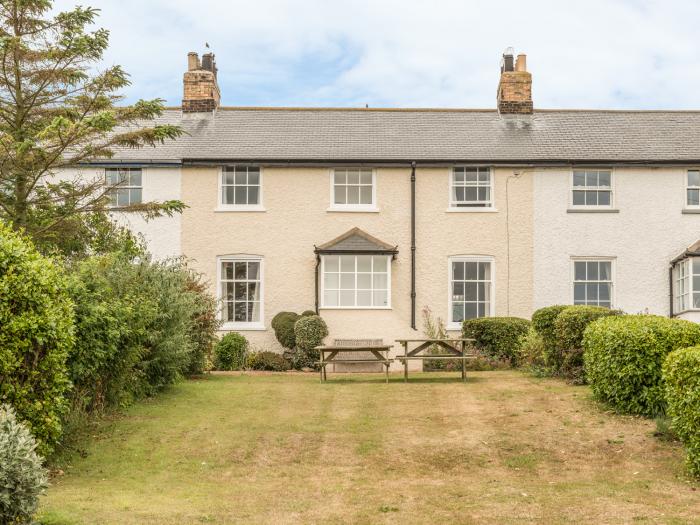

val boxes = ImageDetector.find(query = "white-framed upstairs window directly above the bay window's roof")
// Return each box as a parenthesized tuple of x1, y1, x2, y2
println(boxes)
(331, 168, 377, 211)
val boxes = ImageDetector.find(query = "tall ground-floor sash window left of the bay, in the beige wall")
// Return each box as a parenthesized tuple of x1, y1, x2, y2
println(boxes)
(219, 256, 263, 329)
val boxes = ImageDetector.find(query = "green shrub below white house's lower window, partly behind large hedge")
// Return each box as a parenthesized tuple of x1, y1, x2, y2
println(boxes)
(549, 305, 622, 385)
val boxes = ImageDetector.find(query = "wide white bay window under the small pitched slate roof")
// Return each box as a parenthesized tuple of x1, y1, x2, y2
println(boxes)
(321, 255, 391, 309)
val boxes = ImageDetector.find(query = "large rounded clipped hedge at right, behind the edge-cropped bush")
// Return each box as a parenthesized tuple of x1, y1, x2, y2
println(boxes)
(583, 315, 700, 416)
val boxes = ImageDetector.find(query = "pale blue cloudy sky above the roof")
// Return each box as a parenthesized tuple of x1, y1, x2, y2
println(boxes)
(55, 0, 700, 109)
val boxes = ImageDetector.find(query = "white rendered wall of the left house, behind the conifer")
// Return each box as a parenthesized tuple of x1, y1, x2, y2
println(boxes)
(55, 167, 182, 259)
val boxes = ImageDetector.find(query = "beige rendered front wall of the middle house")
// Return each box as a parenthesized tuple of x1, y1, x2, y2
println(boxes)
(182, 167, 533, 366)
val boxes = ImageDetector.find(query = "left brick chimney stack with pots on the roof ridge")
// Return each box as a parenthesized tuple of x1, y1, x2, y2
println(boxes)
(182, 52, 221, 113)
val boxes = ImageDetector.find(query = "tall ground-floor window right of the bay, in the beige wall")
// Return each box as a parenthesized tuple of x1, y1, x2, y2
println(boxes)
(449, 256, 494, 327)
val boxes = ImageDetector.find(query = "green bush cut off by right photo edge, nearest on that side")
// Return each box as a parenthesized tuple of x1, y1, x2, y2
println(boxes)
(663, 346, 700, 477)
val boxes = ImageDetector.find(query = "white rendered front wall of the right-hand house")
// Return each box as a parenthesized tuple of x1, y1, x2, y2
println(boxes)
(534, 168, 700, 315)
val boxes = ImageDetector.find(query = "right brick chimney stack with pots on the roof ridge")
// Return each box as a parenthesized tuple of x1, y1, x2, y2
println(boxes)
(497, 48, 532, 115)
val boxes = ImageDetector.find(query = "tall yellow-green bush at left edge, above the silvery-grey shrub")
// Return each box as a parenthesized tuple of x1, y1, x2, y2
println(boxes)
(0, 219, 74, 455)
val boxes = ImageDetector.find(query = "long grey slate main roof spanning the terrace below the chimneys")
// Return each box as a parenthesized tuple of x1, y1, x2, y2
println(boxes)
(106, 108, 700, 163)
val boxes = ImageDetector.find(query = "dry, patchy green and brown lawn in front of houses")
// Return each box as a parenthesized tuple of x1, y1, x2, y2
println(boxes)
(41, 371, 700, 524)
